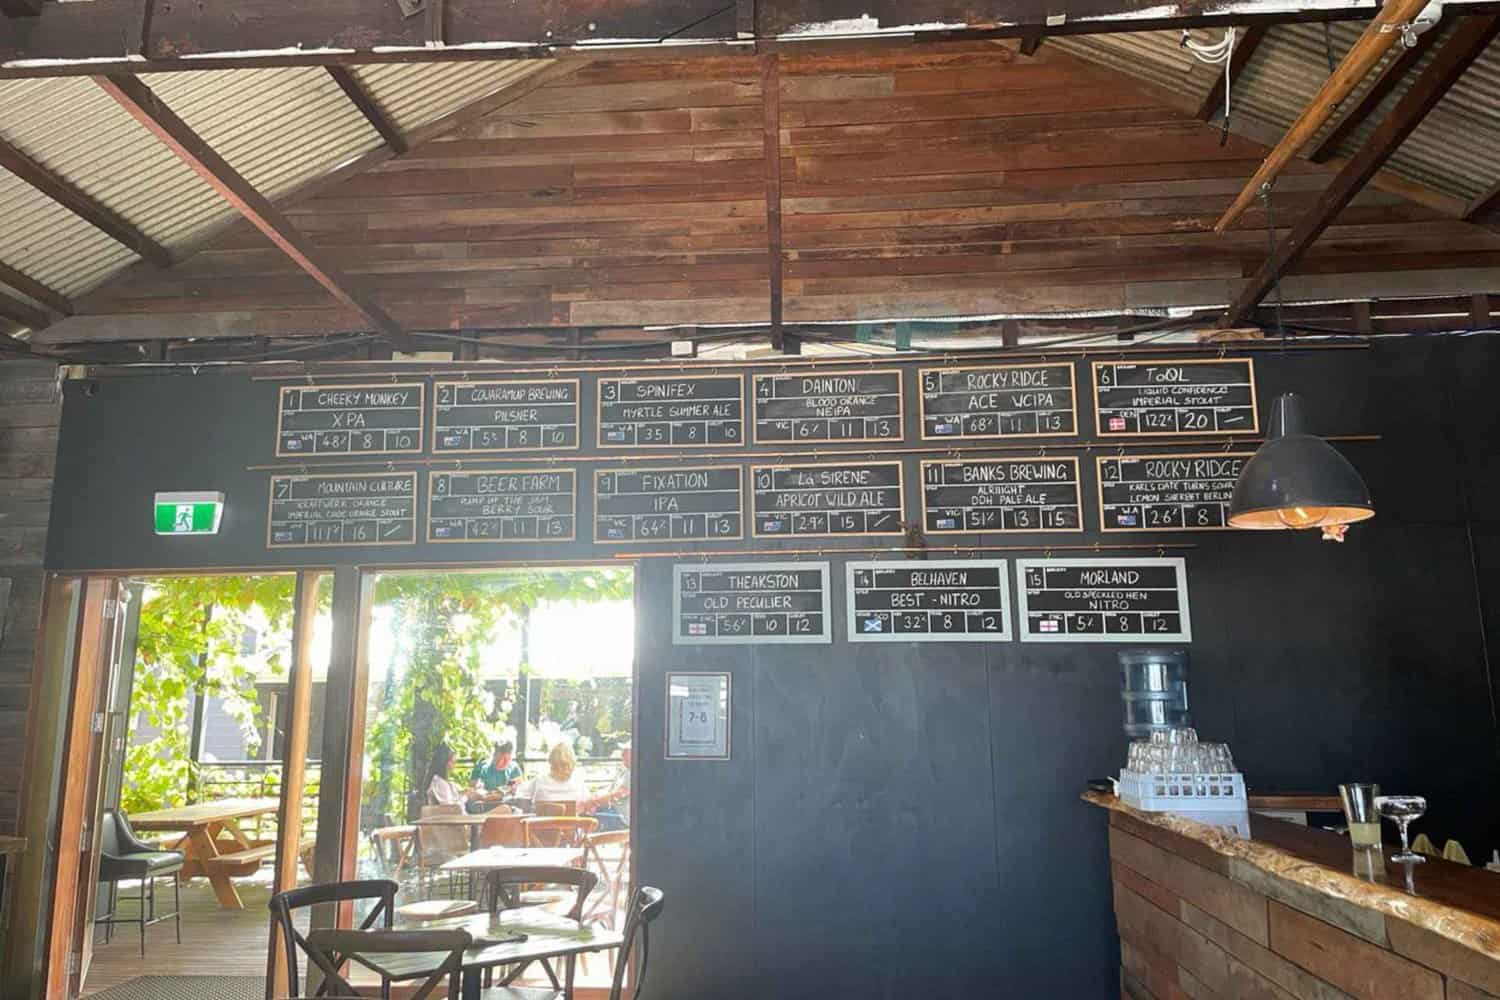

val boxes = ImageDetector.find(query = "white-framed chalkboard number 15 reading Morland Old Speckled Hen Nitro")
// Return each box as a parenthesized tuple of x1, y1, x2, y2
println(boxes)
(1016, 558, 1193, 642)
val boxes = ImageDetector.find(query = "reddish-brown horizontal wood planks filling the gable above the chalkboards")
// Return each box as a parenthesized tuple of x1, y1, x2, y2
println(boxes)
(38, 42, 1500, 343)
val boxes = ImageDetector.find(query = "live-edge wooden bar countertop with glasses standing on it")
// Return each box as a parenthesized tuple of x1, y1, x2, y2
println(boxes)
(1083, 792, 1500, 961)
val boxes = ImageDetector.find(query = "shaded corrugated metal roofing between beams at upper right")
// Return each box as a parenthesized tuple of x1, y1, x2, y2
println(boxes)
(1049, 21, 1500, 199)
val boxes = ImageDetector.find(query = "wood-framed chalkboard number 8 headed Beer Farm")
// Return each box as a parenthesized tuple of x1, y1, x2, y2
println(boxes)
(428, 469, 578, 541)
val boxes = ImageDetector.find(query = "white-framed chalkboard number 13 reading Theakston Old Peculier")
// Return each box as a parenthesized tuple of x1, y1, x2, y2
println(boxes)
(672, 562, 833, 646)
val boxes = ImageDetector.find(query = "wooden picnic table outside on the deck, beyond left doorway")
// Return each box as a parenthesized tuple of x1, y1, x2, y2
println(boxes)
(129, 799, 281, 910)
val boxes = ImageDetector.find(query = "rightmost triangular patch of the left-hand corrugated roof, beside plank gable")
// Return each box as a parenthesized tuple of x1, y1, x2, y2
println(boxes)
(354, 58, 548, 132)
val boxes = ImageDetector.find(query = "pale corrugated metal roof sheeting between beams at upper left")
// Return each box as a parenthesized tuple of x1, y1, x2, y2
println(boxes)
(0, 60, 546, 325)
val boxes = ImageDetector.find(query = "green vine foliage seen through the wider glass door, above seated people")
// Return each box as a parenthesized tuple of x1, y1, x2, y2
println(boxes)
(363, 570, 633, 823)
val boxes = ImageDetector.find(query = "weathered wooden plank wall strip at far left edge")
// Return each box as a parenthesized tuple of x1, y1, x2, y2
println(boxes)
(0, 361, 62, 834)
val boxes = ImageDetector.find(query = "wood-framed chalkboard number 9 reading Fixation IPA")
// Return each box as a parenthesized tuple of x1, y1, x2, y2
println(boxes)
(594, 465, 744, 544)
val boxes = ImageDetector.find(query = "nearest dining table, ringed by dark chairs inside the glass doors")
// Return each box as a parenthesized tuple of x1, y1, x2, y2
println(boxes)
(345, 907, 624, 1000)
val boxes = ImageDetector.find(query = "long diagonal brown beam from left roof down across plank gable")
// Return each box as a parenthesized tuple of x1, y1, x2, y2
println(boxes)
(95, 76, 413, 348)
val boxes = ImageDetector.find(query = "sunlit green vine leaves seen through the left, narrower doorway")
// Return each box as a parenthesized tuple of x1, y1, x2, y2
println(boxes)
(122, 576, 296, 813)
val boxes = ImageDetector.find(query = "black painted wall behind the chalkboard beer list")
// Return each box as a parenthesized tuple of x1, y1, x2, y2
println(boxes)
(41, 339, 1500, 999)
